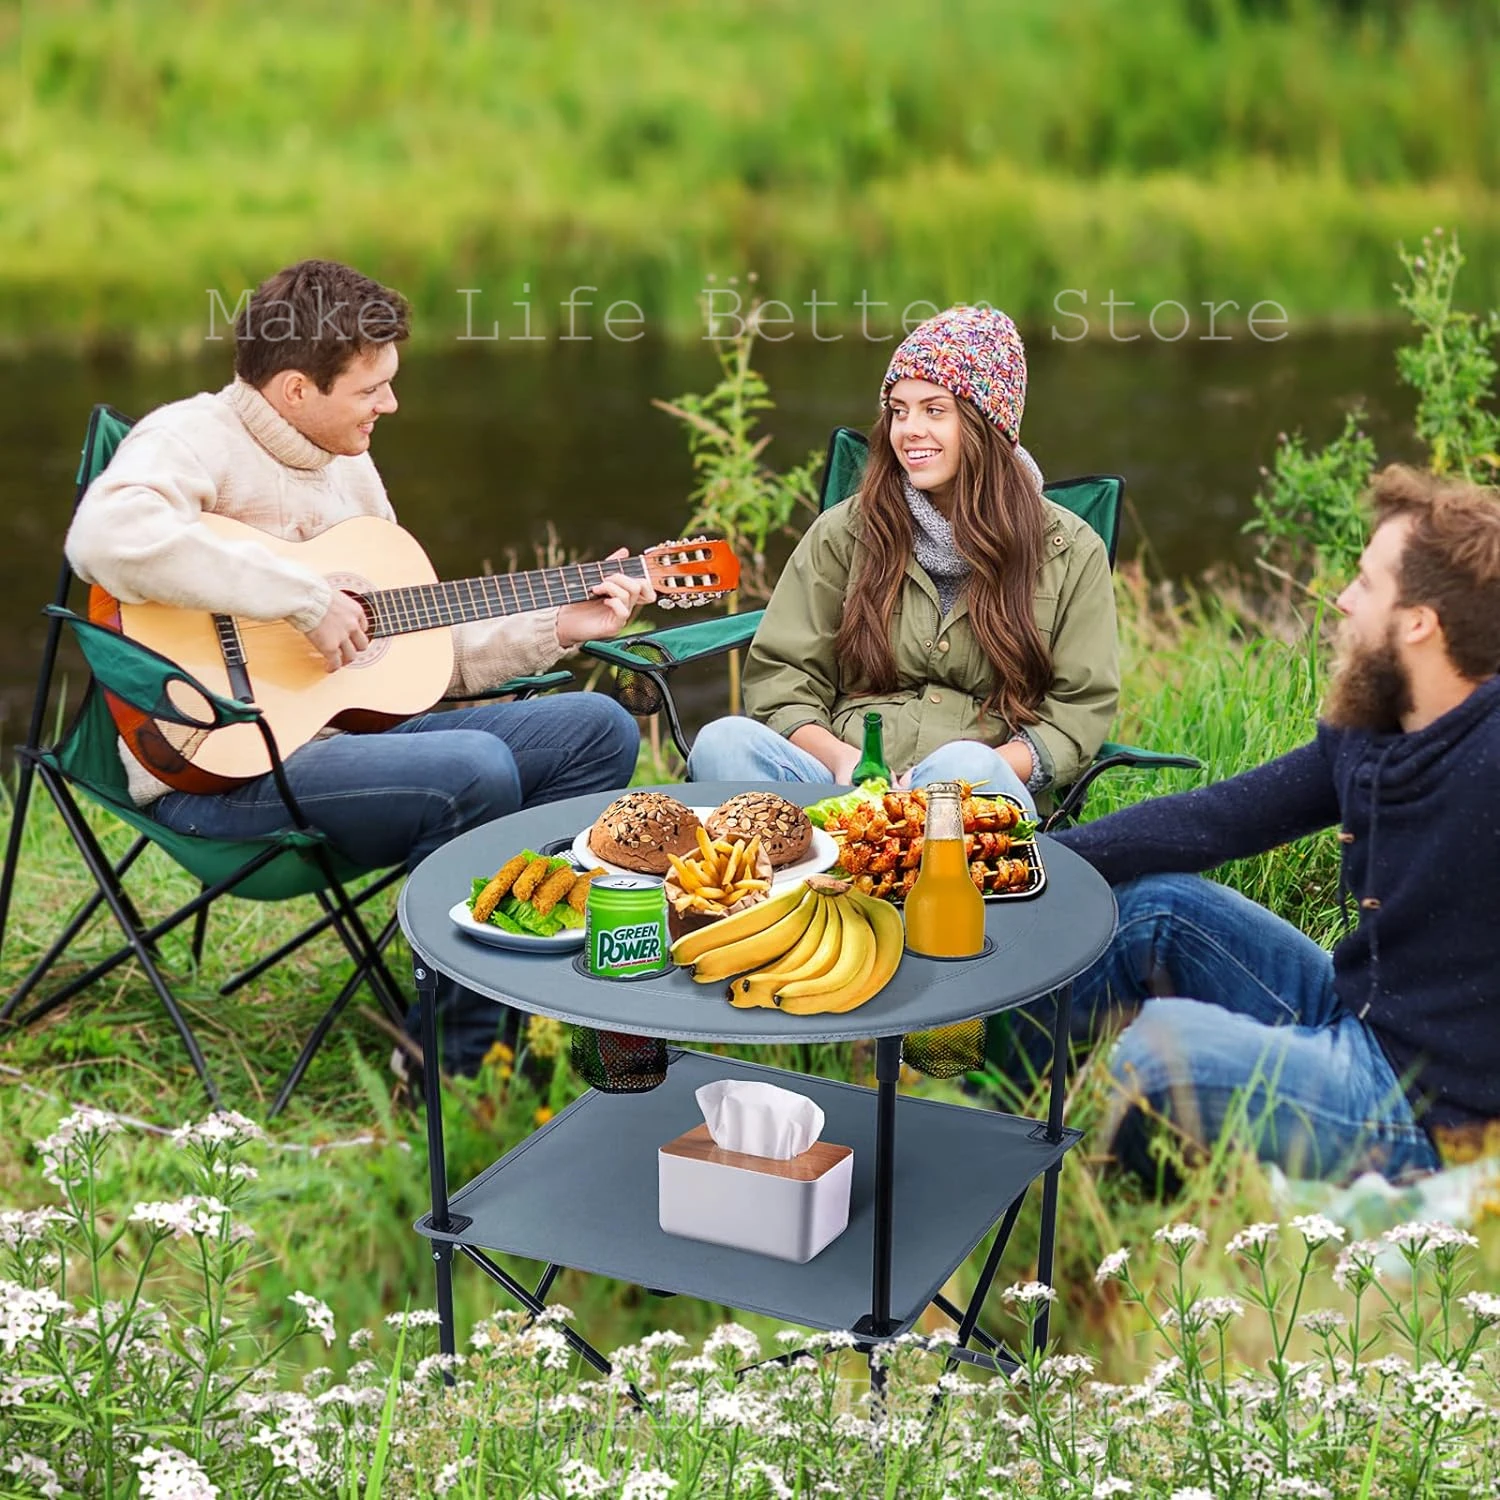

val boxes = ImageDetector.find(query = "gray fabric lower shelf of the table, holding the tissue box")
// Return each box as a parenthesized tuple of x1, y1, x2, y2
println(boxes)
(417, 1052, 1080, 1332)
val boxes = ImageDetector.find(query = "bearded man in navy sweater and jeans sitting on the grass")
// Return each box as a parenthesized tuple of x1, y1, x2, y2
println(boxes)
(1058, 467, 1500, 1179)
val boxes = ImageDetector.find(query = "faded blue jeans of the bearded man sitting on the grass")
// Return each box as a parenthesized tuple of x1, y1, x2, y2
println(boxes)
(1073, 875, 1439, 1179)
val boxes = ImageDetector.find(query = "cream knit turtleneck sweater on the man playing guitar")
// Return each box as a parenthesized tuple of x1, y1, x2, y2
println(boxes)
(66, 380, 564, 806)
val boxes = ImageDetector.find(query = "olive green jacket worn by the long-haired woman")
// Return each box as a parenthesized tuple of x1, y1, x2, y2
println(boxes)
(744, 500, 1121, 786)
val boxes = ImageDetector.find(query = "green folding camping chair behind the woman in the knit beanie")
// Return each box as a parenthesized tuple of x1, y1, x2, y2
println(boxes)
(582, 428, 1203, 828)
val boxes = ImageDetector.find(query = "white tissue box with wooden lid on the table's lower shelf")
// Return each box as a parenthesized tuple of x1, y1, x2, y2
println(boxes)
(657, 1125, 854, 1263)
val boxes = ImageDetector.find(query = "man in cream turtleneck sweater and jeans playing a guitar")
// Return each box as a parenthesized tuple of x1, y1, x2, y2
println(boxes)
(66, 261, 656, 1073)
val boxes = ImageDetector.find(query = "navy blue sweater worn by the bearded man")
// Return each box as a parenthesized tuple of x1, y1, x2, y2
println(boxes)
(1056, 678, 1500, 1125)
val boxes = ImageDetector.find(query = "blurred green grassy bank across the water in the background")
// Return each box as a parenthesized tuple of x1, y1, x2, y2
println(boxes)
(0, 0, 1500, 345)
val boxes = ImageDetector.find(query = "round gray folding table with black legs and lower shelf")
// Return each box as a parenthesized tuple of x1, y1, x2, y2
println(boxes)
(399, 783, 1115, 1373)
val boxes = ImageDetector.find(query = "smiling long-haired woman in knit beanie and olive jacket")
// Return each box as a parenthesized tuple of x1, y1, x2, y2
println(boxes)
(689, 308, 1119, 807)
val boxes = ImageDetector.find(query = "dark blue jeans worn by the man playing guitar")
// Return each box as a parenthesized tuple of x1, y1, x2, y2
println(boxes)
(152, 693, 641, 1073)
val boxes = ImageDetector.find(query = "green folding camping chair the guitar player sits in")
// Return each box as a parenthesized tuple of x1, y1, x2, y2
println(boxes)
(0, 407, 572, 1116)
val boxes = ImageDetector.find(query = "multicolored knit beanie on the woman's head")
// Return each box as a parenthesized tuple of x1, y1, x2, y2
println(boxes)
(881, 308, 1026, 443)
